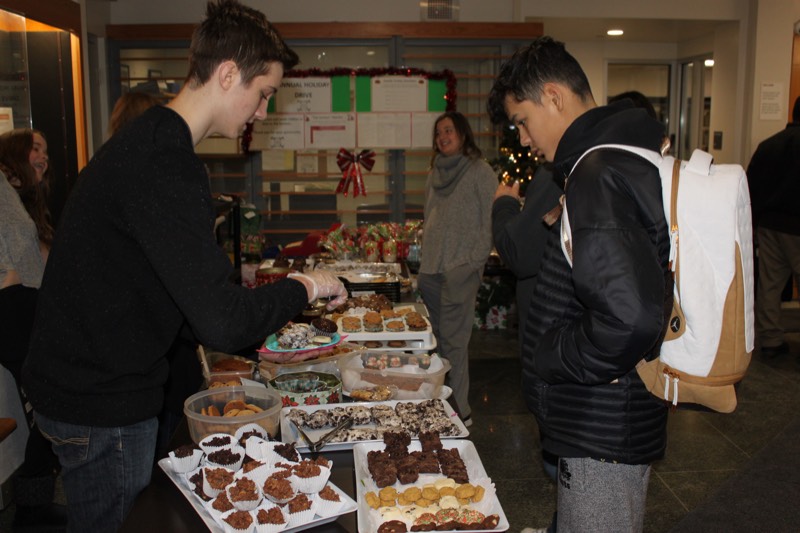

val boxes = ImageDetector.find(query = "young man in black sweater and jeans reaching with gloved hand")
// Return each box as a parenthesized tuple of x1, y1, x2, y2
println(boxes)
(23, 0, 346, 532)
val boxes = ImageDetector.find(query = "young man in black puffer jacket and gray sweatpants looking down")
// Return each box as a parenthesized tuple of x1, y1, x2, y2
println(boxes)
(489, 37, 670, 532)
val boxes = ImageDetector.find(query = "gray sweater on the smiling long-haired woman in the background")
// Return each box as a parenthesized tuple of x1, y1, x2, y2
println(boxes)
(419, 154, 497, 274)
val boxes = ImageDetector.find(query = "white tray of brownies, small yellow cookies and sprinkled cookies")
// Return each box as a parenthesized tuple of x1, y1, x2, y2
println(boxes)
(353, 432, 508, 532)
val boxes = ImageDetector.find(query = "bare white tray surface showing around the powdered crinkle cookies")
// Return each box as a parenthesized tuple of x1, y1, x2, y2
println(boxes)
(281, 400, 469, 455)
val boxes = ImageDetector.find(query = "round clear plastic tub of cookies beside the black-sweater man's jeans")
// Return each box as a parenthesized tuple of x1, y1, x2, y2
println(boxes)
(183, 387, 282, 443)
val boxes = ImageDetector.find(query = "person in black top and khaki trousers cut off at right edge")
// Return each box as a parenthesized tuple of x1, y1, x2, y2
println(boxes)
(747, 97, 800, 357)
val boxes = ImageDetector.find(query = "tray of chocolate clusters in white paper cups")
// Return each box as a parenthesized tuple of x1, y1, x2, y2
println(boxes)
(158, 425, 356, 533)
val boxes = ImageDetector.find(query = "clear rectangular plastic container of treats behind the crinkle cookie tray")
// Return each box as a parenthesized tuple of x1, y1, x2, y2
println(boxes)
(339, 350, 450, 400)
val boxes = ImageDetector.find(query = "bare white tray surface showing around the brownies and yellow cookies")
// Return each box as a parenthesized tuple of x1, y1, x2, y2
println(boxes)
(353, 440, 509, 533)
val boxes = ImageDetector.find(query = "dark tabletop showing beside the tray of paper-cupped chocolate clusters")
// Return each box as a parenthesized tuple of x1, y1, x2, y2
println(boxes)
(120, 418, 358, 533)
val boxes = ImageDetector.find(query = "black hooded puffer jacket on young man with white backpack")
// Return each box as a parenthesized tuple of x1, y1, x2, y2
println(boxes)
(522, 102, 670, 464)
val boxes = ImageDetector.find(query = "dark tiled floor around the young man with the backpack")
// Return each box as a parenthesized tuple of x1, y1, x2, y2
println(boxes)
(0, 309, 800, 533)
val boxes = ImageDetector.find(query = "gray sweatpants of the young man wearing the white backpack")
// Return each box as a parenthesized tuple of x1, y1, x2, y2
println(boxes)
(558, 457, 650, 533)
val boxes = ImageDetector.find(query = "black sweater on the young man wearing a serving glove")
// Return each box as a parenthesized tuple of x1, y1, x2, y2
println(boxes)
(23, 107, 307, 426)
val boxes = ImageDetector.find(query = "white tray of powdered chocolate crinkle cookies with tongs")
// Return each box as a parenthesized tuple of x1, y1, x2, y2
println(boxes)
(281, 399, 469, 450)
